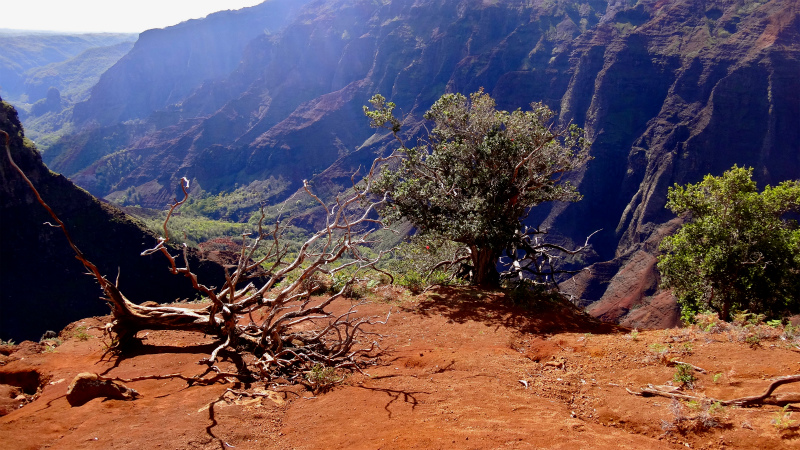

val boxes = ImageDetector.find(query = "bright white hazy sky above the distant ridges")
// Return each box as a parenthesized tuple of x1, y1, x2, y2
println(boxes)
(0, 0, 264, 33)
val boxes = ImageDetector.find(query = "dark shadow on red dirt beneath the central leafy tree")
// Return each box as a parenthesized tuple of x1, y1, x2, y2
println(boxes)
(409, 286, 629, 334)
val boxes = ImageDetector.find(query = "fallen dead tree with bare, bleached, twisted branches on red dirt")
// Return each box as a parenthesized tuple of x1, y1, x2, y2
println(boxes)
(0, 132, 404, 381)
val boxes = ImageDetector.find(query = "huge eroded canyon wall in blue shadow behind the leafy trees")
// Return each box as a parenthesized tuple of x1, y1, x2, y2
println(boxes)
(39, 0, 800, 326)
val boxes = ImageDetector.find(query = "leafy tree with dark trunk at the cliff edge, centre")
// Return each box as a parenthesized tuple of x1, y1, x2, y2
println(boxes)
(364, 90, 589, 285)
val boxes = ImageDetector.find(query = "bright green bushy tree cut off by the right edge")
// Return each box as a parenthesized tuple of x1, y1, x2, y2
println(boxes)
(658, 166, 800, 320)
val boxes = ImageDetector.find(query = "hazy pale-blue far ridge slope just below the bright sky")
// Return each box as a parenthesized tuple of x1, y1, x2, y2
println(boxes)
(74, 0, 308, 125)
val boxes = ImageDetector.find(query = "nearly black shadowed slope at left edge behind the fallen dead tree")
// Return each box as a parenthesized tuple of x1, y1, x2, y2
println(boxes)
(0, 100, 224, 341)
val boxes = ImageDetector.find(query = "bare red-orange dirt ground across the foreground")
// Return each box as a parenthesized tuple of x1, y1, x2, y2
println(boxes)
(0, 288, 800, 450)
